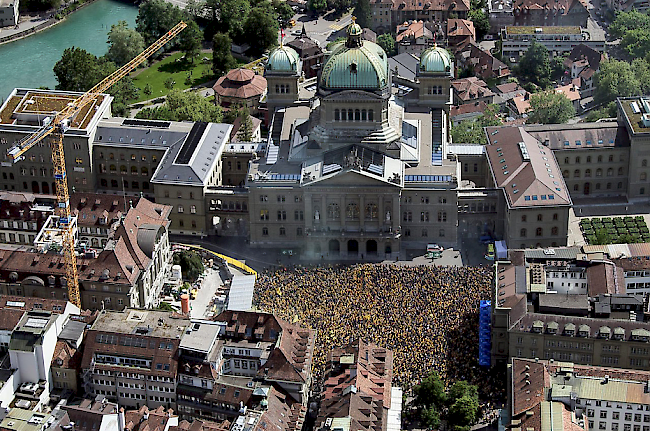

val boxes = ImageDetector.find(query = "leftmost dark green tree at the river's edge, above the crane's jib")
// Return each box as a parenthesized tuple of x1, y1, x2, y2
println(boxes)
(54, 46, 108, 91)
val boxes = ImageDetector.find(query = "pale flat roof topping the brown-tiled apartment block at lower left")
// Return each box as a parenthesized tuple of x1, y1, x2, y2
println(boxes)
(92, 308, 190, 338)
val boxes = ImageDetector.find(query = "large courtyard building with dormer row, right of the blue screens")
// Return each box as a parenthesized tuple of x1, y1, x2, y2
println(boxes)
(492, 247, 650, 370)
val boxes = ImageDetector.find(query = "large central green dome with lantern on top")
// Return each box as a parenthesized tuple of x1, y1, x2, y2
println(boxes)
(320, 20, 389, 90)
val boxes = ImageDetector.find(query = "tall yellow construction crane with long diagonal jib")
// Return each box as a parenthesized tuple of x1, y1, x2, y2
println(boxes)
(7, 21, 187, 307)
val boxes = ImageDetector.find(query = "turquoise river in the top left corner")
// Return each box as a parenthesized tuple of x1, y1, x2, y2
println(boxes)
(0, 0, 138, 100)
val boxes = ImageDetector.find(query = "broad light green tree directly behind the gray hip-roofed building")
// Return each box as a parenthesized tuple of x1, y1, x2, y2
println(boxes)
(136, 89, 223, 123)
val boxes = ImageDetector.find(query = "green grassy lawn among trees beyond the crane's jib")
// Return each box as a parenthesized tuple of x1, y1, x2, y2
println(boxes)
(130, 52, 214, 103)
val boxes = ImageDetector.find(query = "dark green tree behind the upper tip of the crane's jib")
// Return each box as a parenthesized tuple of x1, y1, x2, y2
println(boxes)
(135, 0, 187, 50)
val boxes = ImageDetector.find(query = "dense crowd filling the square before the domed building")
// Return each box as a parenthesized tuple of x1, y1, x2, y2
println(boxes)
(254, 264, 494, 396)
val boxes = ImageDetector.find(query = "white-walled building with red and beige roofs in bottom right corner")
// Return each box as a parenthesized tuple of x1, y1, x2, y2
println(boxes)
(508, 358, 650, 431)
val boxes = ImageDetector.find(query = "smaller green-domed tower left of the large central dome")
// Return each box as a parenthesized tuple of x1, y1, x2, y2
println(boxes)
(264, 44, 302, 115)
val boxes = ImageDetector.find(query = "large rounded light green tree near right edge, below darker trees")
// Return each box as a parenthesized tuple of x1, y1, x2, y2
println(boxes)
(594, 59, 641, 103)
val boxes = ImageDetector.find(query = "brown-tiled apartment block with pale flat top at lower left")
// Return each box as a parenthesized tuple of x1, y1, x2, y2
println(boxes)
(81, 309, 190, 409)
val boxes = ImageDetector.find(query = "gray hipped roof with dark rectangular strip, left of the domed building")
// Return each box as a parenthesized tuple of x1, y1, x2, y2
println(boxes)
(151, 123, 232, 186)
